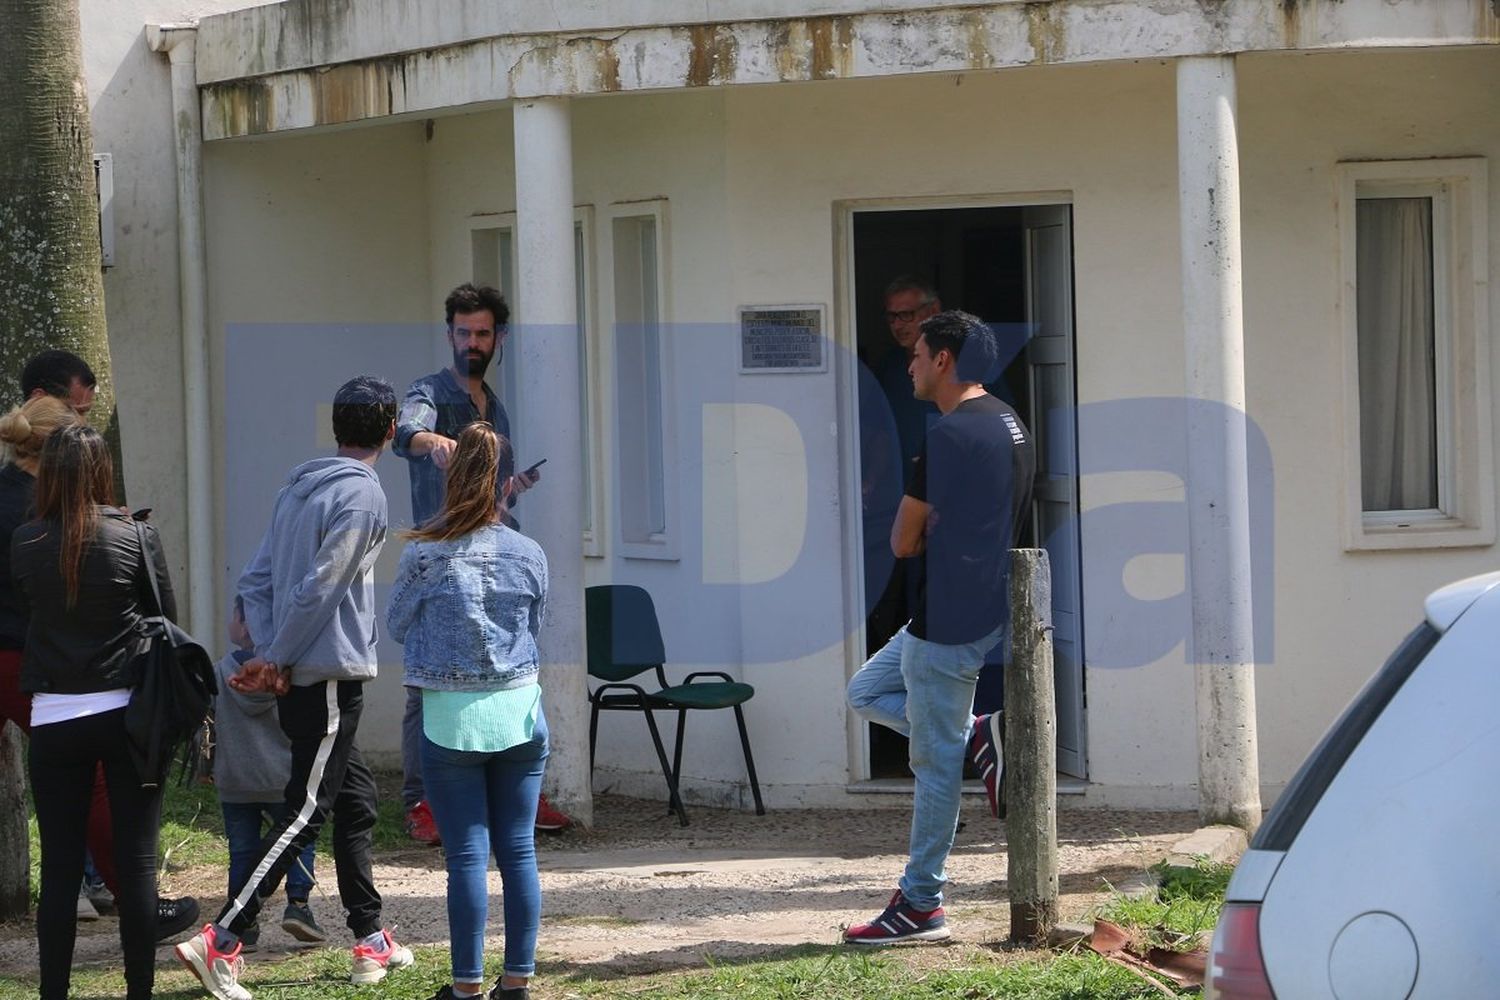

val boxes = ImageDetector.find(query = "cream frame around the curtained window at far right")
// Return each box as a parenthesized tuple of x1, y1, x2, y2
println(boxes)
(1335, 157, 1496, 552)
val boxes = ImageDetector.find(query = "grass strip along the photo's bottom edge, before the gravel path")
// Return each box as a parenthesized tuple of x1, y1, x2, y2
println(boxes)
(0, 946, 1200, 1000)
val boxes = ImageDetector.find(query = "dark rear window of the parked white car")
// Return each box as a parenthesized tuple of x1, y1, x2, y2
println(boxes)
(1250, 622, 1443, 850)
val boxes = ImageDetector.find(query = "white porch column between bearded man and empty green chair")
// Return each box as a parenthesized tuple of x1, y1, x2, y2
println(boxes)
(510, 97, 594, 826)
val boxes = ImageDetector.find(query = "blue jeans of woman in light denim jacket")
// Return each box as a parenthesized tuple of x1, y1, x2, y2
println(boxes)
(422, 711, 548, 984)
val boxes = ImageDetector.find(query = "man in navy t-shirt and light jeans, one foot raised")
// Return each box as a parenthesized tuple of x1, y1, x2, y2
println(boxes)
(845, 310, 1037, 945)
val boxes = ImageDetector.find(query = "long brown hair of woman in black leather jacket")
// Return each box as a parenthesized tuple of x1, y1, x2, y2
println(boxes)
(36, 424, 114, 607)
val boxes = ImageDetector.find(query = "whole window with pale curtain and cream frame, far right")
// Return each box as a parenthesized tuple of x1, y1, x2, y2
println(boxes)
(1338, 156, 1496, 552)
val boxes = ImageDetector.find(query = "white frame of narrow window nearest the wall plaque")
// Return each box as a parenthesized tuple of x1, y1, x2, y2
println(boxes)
(599, 198, 683, 561)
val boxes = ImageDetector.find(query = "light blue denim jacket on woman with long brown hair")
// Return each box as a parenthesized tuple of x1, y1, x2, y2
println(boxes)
(386, 525, 548, 691)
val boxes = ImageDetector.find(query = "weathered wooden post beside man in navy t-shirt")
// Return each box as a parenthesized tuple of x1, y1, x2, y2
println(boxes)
(1005, 549, 1058, 943)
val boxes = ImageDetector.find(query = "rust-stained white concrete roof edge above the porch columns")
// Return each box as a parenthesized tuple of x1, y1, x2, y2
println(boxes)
(198, 0, 1500, 141)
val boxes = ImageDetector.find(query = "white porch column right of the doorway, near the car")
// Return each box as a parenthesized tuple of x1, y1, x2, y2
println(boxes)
(1178, 55, 1260, 831)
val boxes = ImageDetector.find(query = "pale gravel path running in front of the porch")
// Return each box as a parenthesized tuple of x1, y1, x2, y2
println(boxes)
(0, 796, 1197, 973)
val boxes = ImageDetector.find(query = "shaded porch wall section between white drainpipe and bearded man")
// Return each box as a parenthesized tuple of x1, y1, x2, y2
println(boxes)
(204, 124, 441, 763)
